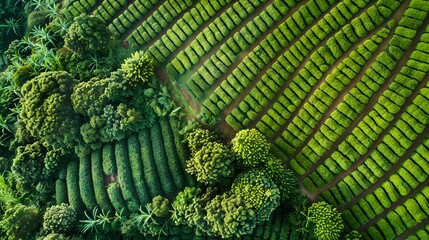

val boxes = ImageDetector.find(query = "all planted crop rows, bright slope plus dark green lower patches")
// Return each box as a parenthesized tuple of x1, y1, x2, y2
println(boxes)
(56, 0, 429, 239)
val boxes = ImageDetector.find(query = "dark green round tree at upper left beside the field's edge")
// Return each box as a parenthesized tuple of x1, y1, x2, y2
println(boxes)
(64, 13, 111, 58)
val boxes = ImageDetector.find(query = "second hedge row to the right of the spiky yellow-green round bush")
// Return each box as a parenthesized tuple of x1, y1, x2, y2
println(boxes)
(167, 0, 265, 77)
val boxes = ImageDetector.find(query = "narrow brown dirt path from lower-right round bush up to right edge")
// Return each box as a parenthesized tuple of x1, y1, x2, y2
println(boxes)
(337, 118, 429, 211)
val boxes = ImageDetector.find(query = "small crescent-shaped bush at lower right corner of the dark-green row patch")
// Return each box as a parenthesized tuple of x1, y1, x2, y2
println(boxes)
(171, 187, 201, 225)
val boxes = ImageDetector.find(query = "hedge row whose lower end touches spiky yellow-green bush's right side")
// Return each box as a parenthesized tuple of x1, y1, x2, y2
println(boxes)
(148, 0, 231, 66)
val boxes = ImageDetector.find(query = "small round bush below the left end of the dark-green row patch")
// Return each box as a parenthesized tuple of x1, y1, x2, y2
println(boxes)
(43, 203, 77, 233)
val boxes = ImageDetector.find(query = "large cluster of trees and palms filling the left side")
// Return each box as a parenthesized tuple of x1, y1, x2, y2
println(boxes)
(0, 7, 174, 239)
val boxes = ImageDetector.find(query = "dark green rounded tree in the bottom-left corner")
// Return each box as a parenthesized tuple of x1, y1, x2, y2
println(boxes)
(0, 204, 43, 239)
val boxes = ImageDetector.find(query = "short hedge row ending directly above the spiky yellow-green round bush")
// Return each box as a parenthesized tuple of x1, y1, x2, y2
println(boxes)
(125, 0, 193, 45)
